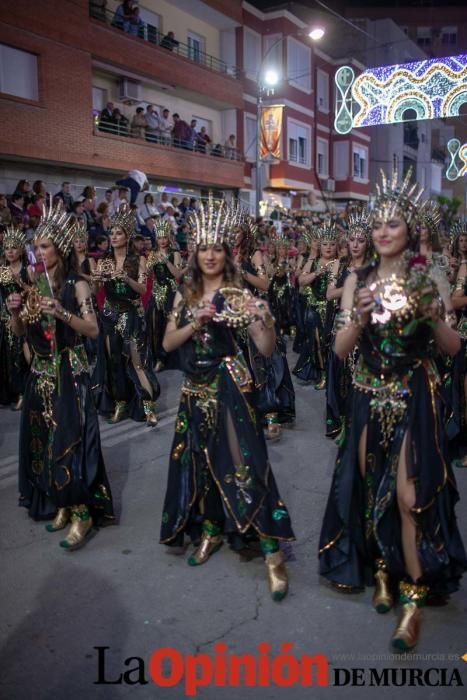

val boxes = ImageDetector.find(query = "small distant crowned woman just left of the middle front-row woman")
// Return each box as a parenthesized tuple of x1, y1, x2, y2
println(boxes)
(146, 220, 183, 370)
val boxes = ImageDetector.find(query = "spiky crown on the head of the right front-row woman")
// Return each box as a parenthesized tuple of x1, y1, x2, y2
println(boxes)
(370, 168, 423, 226)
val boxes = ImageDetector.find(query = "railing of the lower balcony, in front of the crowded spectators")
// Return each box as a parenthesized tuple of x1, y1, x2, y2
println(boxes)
(93, 115, 244, 161)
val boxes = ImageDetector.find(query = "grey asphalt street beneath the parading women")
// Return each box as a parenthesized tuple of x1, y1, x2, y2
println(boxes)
(0, 356, 467, 700)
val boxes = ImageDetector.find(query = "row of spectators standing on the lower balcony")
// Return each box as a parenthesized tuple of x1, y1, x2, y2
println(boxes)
(97, 102, 239, 160)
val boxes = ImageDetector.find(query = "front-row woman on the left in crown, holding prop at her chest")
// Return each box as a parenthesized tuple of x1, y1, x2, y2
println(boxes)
(7, 206, 113, 551)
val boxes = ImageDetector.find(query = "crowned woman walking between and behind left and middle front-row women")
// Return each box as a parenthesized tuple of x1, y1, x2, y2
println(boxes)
(92, 207, 160, 426)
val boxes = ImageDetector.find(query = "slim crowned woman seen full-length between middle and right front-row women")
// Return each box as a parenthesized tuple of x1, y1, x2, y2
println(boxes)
(293, 222, 337, 389)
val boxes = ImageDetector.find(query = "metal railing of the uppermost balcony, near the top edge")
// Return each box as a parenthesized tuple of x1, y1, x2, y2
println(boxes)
(89, 0, 241, 79)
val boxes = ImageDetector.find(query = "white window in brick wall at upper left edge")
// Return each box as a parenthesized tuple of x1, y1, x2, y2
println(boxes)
(0, 43, 39, 102)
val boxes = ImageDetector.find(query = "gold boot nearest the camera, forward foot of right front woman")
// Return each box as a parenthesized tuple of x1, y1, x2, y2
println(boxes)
(391, 581, 429, 651)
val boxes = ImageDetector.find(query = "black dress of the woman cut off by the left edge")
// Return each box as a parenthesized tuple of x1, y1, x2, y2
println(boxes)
(0, 265, 29, 406)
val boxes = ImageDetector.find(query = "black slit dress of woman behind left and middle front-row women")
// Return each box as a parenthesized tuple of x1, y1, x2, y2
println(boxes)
(92, 256, 160, 421)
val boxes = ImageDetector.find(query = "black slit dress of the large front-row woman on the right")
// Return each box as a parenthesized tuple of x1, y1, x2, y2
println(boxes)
(319, 260, 467, 595)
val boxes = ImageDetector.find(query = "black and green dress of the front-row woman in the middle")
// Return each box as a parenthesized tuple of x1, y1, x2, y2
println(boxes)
(161, 292, 294, 546)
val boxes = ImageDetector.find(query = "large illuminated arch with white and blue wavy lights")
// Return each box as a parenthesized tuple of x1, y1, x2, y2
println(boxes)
(334, 54, 467, 133)
